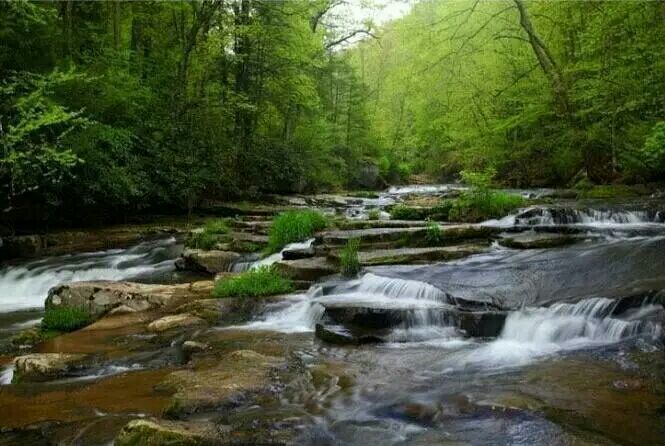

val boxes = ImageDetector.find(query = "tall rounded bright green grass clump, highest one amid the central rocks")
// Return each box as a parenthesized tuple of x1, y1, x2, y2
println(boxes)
(268, 211, 329, 252)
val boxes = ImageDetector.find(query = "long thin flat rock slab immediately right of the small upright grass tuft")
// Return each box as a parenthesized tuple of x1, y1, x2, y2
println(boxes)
(330, 245, 487, 266)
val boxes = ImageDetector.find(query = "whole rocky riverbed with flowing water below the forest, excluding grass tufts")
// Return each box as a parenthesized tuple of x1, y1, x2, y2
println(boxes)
(0, 185, 665, 445)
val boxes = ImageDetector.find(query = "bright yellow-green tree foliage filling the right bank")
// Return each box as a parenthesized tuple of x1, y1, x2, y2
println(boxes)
(351, 0, 665, 187)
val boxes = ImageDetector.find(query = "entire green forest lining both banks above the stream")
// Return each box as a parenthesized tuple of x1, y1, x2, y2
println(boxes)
(0, 0, 665, 228)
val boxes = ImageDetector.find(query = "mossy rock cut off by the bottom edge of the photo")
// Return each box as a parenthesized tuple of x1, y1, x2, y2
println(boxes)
(114, 419, 219, 446)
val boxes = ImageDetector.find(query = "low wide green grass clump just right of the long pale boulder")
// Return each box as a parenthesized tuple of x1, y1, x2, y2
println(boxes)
(213, 266, 294, 297)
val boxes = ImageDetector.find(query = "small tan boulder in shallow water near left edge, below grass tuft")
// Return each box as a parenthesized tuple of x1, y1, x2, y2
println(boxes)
(14, 353, 87, 382)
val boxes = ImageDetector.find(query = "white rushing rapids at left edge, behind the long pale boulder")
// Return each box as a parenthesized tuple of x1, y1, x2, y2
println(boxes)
(0, 237, 181, 312)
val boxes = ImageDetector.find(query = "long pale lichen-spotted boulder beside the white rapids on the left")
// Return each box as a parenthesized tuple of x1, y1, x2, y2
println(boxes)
(45, 280, 209, 317)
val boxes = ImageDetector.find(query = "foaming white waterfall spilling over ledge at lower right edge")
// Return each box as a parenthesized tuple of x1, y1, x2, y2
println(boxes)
(501, 298, 662, 344)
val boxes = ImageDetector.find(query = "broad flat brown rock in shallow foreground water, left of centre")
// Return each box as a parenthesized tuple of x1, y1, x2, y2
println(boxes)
(160, 350, 284, 416)
